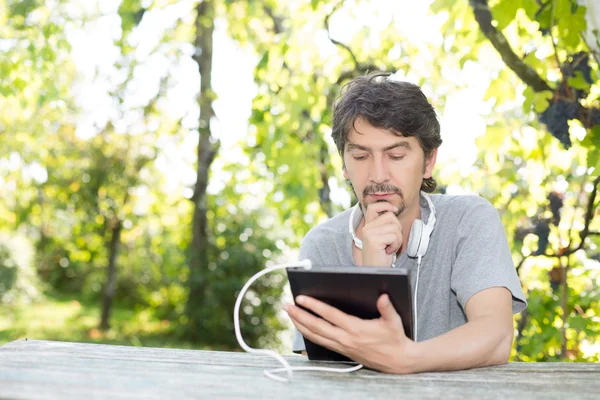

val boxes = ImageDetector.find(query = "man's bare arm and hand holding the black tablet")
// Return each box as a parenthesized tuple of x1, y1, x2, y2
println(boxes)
(284, 287, 513, 374)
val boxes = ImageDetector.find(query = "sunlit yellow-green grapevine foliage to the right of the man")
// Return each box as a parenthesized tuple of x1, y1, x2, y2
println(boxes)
(432, 0, 600, 361)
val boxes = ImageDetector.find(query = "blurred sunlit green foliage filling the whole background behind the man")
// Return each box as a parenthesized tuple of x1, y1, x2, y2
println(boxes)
(0, 0, 600, 361)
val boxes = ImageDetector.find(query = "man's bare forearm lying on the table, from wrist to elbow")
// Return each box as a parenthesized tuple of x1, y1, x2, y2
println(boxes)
(398, 316, 513, 373)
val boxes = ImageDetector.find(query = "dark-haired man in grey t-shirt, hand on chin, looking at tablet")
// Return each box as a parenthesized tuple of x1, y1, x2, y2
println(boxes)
(284, 72, 527, 374)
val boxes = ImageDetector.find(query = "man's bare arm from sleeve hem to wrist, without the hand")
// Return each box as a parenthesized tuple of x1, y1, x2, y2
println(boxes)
(397, 287, 514, 373)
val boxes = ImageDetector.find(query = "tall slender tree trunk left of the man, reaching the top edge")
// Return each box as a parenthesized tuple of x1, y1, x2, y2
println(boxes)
(186, 0, 218, 339)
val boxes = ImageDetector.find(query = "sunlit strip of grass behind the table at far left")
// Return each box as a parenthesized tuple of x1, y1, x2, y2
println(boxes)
(0, 296, 201, 349)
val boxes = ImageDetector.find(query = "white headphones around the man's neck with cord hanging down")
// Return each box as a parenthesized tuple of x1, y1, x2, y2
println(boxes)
(348, 191, 435, 342)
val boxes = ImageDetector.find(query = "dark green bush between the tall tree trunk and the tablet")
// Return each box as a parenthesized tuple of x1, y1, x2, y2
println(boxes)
(195, 202, 286, 349)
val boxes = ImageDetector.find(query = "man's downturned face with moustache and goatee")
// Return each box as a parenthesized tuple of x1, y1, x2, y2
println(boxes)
(344, 118, 437, 215)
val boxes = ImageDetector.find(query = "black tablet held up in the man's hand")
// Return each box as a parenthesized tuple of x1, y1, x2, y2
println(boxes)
(287, 265, 413, 362)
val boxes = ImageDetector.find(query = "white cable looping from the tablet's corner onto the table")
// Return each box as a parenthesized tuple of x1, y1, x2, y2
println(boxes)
(233, 259, 363, 382)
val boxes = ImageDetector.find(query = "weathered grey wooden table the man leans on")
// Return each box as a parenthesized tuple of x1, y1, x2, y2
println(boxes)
(0, 340, 600, 400)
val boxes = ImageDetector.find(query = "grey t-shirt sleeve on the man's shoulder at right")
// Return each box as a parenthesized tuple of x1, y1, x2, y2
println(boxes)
(450, 198, 527, 314)
